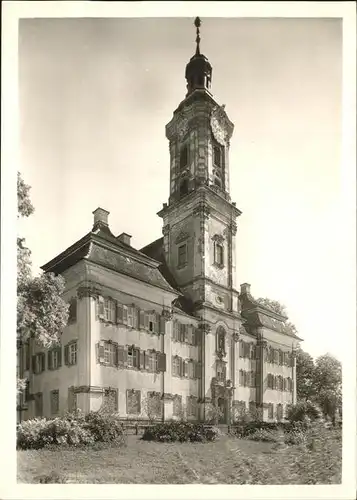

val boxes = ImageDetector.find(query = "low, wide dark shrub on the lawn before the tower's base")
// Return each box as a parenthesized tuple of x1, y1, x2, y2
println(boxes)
(142, 421, 218, 443)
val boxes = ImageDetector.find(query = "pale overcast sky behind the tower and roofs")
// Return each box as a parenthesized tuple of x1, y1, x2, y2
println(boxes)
(19, 17, 345, 356)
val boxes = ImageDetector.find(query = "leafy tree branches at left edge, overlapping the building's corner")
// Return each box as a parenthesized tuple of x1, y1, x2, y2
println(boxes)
(17, 173, 68, 390)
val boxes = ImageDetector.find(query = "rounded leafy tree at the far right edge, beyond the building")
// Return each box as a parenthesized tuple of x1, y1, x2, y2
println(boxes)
(314, 354, 342, 423)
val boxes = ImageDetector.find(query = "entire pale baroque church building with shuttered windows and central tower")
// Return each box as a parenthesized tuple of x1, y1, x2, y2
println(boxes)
(18, 18, 301, 423)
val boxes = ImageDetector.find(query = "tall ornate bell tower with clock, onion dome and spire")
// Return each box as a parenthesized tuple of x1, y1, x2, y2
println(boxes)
(158, 18, 241, 315)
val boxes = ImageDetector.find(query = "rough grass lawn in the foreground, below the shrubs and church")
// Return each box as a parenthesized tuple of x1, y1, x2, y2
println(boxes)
(17, 432, 342, 484)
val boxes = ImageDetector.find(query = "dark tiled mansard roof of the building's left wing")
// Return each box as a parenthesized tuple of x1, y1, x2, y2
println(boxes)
(42, 226, 176, 292)
